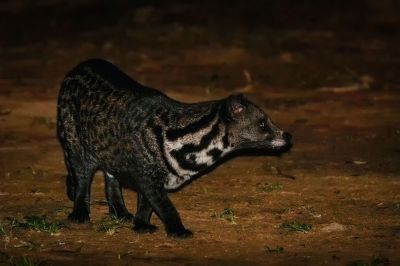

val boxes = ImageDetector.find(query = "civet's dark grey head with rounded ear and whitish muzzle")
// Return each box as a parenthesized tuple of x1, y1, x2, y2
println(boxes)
(223, 94, 292, 152)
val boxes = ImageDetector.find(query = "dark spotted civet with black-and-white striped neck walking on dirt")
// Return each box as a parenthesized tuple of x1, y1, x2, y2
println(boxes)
(57, 59, 290, 237)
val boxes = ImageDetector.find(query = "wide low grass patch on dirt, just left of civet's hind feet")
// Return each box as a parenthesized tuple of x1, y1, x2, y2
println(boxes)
(10, 215, 64, 234)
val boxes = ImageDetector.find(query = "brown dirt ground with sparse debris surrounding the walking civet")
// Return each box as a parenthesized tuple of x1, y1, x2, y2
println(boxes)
(0, 1, 400, 265)
